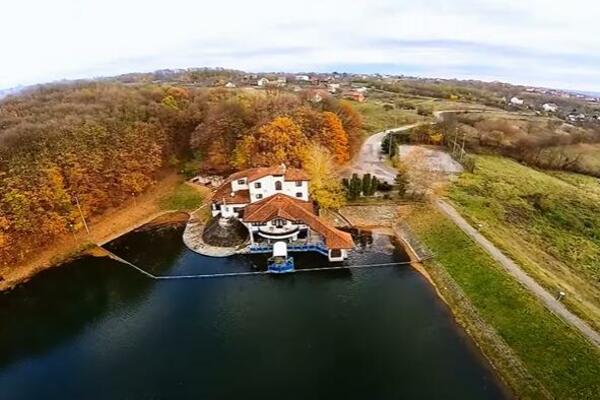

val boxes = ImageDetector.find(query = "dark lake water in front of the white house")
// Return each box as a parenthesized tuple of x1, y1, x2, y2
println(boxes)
(0, 229, 507, 400)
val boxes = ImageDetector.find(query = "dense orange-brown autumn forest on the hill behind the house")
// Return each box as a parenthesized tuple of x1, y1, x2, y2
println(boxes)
(0, 82, 362, 267)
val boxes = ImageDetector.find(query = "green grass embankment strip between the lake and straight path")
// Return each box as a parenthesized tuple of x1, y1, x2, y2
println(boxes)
(408, 207, 600, 399)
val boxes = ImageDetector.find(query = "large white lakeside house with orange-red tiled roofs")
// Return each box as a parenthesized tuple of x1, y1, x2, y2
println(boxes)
(211, 165, 354, 261)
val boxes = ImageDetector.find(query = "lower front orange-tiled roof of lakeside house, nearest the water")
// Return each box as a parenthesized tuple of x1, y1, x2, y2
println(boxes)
(244, 194, 354, 249)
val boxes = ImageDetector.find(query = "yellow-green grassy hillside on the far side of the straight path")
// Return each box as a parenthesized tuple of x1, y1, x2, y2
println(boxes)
(449, 156, 600, 329)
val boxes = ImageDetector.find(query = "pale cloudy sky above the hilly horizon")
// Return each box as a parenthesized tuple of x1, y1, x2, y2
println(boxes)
(0, 0, 600, 92)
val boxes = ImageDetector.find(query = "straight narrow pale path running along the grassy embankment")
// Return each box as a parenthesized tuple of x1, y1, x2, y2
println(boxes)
(435, 199, 600, 347)
